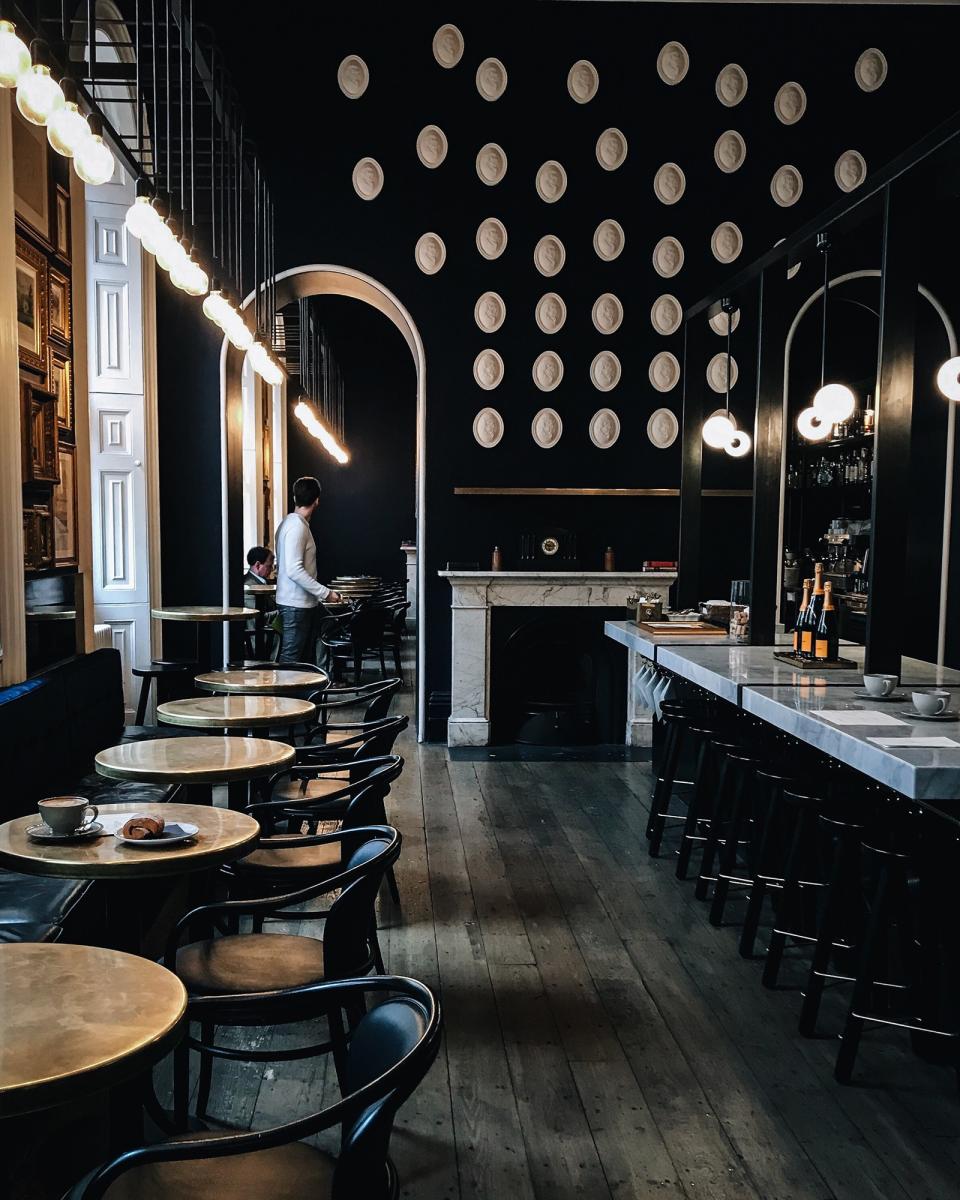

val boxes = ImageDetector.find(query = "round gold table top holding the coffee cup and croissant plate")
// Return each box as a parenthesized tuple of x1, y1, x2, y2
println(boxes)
(0, 796, 260, 883)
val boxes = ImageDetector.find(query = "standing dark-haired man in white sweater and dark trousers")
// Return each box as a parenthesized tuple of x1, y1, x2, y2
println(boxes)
(274, 475, 342, 662)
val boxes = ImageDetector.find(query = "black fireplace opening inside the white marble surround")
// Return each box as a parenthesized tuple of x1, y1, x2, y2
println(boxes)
(491, 607, 626, 746)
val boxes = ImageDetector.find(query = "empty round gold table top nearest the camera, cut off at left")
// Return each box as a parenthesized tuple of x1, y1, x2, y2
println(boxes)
(0, 940, 187, 1117)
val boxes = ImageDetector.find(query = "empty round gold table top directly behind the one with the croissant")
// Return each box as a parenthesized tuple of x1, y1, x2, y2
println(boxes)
(94, 736, 295, 784)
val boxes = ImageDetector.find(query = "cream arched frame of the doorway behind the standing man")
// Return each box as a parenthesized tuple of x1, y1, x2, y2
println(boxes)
(221, 264, 426, 740)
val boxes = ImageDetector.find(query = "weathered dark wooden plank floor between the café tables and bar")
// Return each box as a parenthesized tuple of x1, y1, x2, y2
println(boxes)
(170, 667, 960, 1200)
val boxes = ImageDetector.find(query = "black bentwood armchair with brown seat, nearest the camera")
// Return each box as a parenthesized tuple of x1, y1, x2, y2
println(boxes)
(67, 976, 442, 1200)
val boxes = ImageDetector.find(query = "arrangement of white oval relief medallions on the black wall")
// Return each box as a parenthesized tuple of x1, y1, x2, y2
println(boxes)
(337, 24, 887, 450)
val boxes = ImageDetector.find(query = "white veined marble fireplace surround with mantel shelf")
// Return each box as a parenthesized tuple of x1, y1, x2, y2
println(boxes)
(438, 571, 677, 746)
